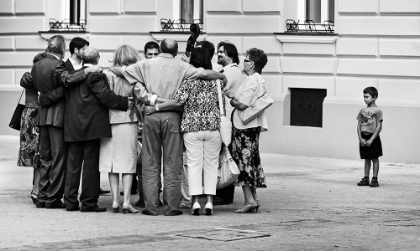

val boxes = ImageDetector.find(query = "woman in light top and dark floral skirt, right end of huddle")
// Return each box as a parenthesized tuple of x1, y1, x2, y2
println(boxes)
(230, 48, 268, 213)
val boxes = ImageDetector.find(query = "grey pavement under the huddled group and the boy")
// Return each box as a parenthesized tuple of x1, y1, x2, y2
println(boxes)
(0, 136, 420, 251)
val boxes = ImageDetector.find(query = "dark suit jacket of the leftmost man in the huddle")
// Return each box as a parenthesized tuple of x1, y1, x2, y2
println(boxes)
(21, 54, 86, 128)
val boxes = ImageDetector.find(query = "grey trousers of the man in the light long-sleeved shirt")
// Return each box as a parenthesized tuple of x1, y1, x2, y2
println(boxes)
(142, 112, 183, 214)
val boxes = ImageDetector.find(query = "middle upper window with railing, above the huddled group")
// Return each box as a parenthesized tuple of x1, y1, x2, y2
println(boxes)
(160, 0, 203, 32)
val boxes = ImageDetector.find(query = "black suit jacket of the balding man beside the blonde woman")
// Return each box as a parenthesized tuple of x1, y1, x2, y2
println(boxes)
(64, 67, 128, 142)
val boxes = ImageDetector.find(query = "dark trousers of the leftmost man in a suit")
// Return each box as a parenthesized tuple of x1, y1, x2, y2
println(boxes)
(38, 126, 66, 203)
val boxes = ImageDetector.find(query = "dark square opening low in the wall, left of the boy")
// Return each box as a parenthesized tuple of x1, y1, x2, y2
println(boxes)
(290, 88, 327, 127)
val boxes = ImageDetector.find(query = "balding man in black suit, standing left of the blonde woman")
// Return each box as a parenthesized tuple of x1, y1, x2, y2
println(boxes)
(64, 47, 132, 212)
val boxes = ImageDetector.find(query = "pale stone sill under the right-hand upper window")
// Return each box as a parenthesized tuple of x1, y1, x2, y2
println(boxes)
(274, 32, 340, 44)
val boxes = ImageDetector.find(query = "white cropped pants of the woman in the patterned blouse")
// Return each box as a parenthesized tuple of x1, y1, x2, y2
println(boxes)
(184, 131, 222, 195)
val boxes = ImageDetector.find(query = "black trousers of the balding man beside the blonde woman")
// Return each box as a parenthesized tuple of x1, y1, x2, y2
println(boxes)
(64, 139, 100, 207)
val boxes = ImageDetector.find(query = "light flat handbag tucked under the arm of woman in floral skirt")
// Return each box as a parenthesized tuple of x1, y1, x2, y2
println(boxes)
(238, 76, 274, 125)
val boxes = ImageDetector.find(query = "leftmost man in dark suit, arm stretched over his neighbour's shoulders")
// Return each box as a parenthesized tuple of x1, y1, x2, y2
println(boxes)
(24, 35, 98, 208)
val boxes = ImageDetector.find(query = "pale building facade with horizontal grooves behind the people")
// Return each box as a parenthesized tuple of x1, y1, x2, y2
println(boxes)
(0, 0, 420, 163)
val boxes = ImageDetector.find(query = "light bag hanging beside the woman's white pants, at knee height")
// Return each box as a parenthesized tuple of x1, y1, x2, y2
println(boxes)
(216, 145, 240, 189)
